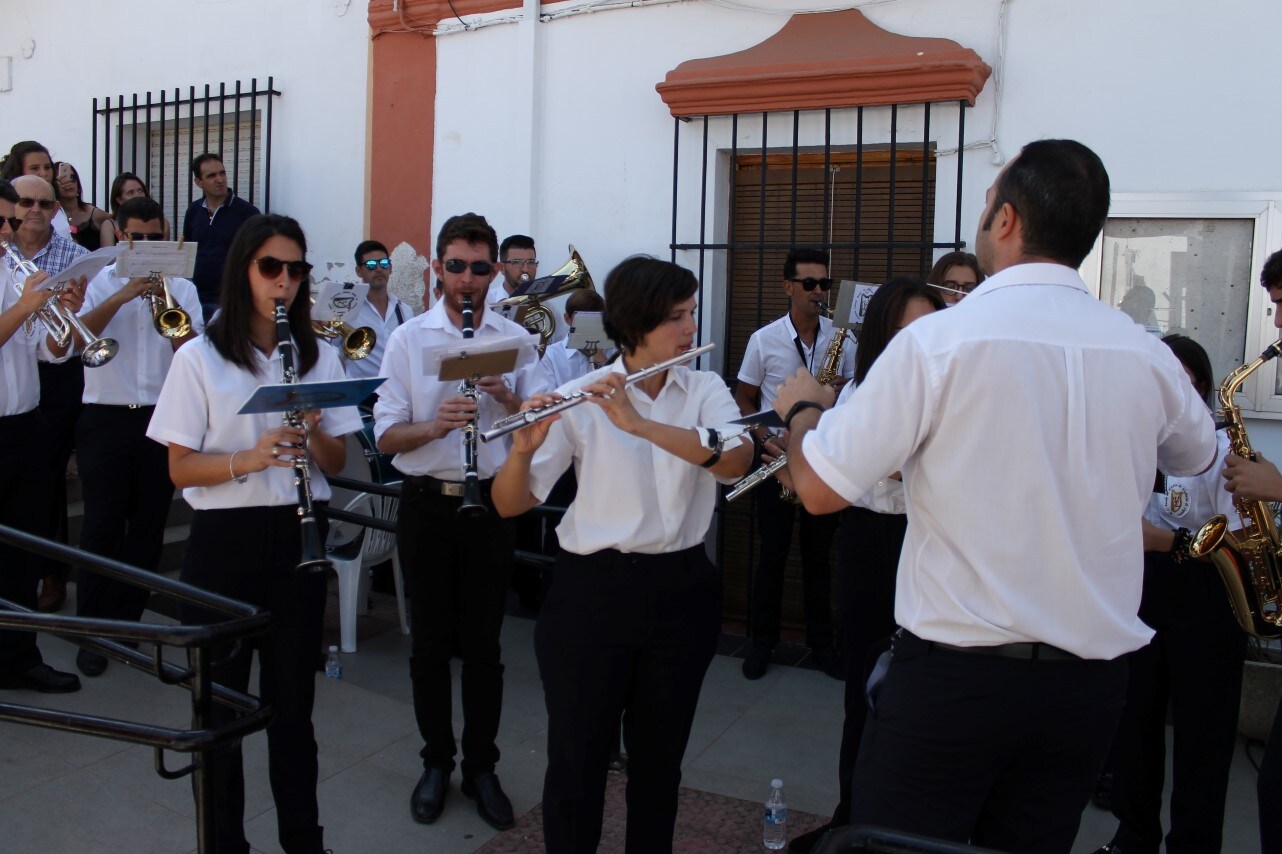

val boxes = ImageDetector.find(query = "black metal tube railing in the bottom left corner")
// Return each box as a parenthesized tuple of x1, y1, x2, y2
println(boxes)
(0, 526, 271, 854)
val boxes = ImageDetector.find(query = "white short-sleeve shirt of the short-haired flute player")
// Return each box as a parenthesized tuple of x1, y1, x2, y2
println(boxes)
(529, 359, 744, 554)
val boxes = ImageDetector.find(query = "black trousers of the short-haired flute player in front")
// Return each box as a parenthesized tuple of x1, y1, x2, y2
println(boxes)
(535, 545, 720, 854)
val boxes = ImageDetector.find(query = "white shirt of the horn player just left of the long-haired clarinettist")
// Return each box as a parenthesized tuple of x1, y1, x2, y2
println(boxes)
(81, 264, 205, 406)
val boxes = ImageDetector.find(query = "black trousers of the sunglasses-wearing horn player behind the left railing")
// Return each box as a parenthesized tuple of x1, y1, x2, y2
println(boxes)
(76, 404, 173, 621)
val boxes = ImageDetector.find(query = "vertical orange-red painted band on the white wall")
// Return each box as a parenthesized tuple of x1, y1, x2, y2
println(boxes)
(365, 32, 436, 258)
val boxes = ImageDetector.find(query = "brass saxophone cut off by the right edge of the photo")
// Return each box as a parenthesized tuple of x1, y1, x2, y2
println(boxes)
(1188, 341, 1282, 639)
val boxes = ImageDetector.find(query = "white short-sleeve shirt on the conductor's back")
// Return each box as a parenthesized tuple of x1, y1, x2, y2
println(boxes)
(804, 264, 1215, 659)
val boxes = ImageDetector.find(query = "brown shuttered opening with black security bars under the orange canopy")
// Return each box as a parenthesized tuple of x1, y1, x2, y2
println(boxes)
(669, 100, 968, 624)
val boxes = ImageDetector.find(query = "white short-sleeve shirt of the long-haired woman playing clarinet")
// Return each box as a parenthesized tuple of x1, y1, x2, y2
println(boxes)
(147, 335, 360, 510)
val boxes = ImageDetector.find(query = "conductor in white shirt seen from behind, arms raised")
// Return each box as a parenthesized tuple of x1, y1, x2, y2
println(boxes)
(774, 140, 1217, 854)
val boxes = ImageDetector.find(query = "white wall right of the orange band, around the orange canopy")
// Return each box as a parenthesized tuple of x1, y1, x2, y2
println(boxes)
(432, 0, 1282, 448)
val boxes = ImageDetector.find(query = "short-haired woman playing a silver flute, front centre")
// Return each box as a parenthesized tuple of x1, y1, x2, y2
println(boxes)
(492, 256, 753, 854)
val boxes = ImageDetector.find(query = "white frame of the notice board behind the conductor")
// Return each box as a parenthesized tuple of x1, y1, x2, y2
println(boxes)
(1081, 190, 1282, 421)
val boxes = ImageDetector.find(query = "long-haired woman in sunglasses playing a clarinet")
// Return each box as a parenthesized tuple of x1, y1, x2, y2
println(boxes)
(147, 215, 360, 854)
